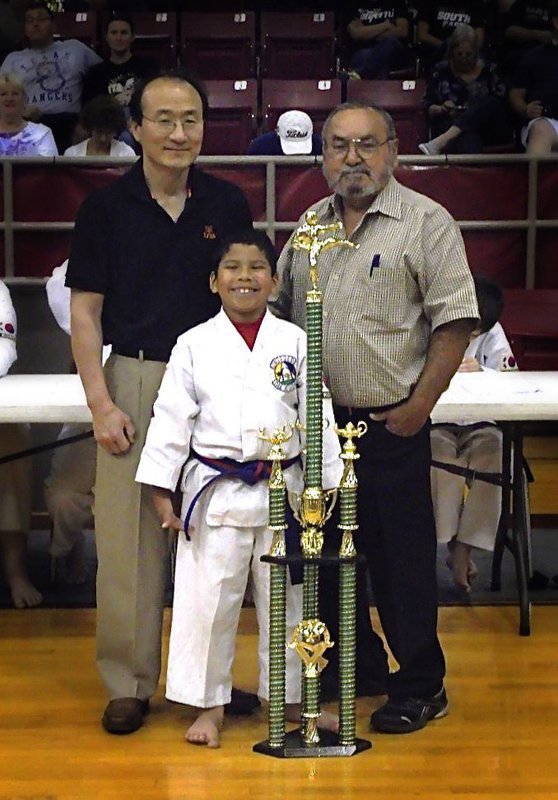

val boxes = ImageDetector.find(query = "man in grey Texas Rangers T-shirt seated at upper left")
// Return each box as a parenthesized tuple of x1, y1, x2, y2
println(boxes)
(0, 1, 101, 153)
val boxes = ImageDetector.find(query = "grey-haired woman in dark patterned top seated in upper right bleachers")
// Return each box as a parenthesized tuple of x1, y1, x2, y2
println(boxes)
(419, 25, 512, 155)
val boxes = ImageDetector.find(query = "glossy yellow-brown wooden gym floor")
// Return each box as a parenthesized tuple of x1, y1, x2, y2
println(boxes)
(0, 606, 558, 800)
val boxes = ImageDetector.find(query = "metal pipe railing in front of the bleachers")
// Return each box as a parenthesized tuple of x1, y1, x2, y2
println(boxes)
(0, 153, 558, 288)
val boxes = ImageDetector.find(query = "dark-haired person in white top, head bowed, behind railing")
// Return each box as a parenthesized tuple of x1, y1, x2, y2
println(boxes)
(64, 97, 136, 158)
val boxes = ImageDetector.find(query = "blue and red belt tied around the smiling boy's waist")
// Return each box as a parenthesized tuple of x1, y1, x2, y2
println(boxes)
(184, 450, 302, 584)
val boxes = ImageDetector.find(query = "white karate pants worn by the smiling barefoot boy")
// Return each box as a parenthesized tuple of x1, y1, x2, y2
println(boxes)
(166, 512, 302, 708)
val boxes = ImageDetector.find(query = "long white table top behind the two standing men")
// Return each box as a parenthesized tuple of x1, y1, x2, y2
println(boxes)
(0, 372, 558, 423)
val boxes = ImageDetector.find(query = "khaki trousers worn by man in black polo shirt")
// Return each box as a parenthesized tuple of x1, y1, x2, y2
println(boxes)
(95, 355, 168, 700)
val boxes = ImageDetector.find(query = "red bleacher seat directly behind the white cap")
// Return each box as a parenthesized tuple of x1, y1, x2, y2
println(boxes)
(262, 78, 341, 133)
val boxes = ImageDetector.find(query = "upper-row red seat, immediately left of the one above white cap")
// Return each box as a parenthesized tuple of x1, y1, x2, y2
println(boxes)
(180, 11, 256, 80)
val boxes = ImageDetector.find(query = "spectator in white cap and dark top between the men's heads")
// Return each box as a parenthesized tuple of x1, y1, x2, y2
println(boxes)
(248, 109, 322, 156)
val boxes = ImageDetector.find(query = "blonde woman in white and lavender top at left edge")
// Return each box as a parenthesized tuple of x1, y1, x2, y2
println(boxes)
(0, 72, 58, 156)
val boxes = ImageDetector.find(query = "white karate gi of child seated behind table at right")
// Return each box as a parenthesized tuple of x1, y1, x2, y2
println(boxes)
(431, 322, 517, 551)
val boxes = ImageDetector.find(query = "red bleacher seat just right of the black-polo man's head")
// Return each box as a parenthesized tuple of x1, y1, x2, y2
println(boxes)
(202, 78, 258, 156)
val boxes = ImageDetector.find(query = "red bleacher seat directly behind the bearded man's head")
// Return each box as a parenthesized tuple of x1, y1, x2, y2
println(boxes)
(347, 78, 425, 153)
